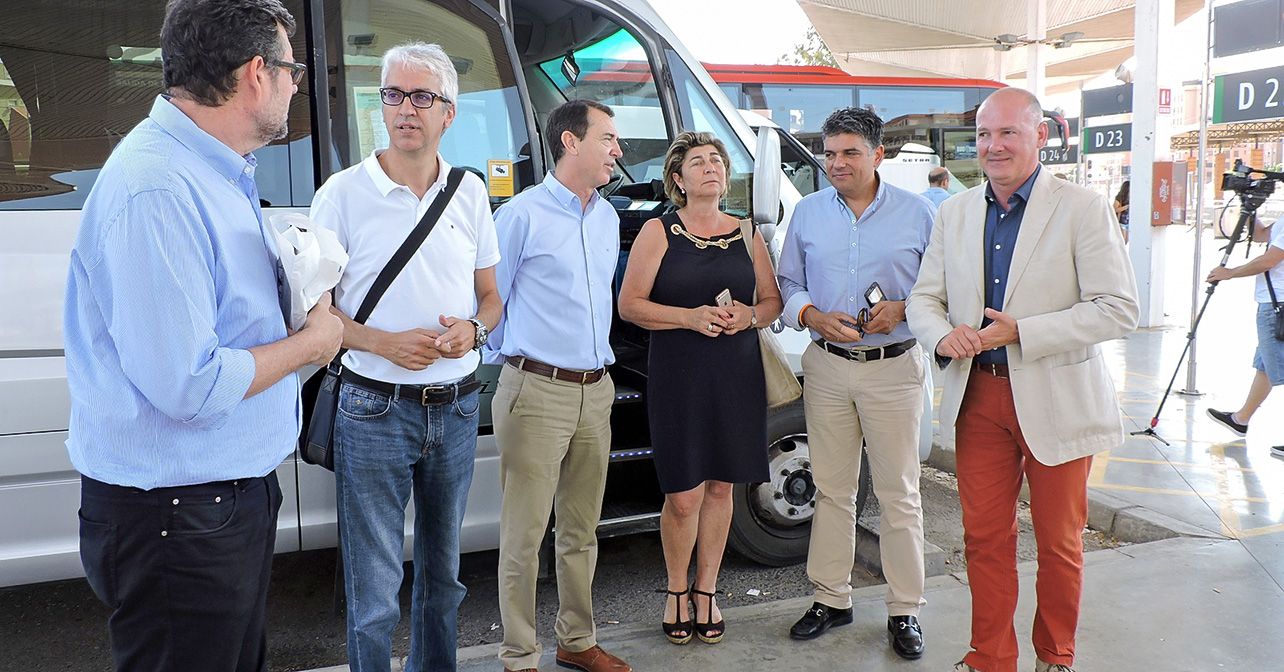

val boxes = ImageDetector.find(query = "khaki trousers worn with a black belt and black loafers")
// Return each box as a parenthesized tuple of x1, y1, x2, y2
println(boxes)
(803, 343, 926, 615)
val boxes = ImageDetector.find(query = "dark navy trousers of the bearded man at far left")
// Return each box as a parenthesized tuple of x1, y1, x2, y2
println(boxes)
(80, 473, 281, 672)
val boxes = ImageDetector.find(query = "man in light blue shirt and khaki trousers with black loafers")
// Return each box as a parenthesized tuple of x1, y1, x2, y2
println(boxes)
(778, 108, 936, 659)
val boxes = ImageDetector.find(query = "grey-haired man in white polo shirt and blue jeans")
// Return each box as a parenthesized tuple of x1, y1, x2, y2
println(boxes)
(312, 42, 502, 672)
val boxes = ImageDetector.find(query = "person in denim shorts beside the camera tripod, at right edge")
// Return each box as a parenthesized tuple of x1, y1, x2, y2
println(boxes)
(1208, 220, 1284, 457)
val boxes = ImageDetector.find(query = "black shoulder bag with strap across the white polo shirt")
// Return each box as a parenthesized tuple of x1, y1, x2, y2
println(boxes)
(299, 167, 464, 472)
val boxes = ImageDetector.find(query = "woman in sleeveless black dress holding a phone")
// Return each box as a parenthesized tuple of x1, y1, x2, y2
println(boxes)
(620, 131, 783, 644)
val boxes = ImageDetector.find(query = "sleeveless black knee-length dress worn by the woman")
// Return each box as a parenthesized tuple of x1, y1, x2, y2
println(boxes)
(647, 213, 768, 492)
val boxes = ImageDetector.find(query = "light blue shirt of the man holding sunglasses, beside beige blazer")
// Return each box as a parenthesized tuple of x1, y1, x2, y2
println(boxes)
(777, 179, 936, 347)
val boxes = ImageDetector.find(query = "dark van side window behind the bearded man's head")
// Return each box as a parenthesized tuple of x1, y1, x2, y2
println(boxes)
(0, 0, 313, 211)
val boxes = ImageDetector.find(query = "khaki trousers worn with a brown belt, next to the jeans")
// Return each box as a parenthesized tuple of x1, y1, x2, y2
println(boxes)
(490, 365, 615, 669)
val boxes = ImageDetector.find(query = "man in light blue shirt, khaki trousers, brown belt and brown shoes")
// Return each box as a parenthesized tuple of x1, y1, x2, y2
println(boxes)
(487, 100, 632, 672)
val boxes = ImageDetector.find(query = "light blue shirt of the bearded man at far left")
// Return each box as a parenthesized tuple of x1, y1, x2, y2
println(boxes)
(63, 96, 300, 490)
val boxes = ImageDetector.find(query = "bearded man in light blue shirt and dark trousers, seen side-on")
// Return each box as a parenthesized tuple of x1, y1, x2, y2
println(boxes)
(64, 0, 343, 672)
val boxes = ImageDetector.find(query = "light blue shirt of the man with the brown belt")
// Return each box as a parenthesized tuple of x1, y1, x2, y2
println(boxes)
(485, 172, 620, 370)
